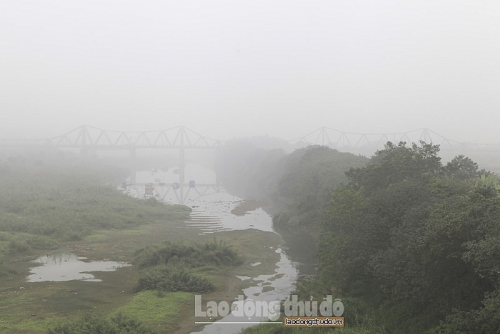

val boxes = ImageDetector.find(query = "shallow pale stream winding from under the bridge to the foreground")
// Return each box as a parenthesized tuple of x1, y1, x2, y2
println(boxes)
(125, 165, 298, 334)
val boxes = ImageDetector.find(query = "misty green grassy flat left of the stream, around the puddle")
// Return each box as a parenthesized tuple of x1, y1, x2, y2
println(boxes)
(0, 155, 282, 333)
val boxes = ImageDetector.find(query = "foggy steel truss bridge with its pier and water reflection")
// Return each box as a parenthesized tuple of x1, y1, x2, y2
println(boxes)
(0, 125, 500, 204)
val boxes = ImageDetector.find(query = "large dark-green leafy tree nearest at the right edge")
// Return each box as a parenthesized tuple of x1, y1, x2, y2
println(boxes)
(319, 142, 500, 333)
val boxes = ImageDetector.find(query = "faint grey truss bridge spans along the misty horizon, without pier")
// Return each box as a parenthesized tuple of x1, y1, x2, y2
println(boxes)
(0, 125, 500, 156)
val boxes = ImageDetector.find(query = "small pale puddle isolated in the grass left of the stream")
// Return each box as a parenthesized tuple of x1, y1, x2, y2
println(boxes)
(27, 251, 130, 282)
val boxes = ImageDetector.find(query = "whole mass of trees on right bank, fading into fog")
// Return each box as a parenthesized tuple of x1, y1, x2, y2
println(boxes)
(226, 141, 500, 334)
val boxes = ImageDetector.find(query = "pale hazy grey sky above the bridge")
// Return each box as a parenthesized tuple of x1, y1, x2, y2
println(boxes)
(0, 0, 500, 142)
